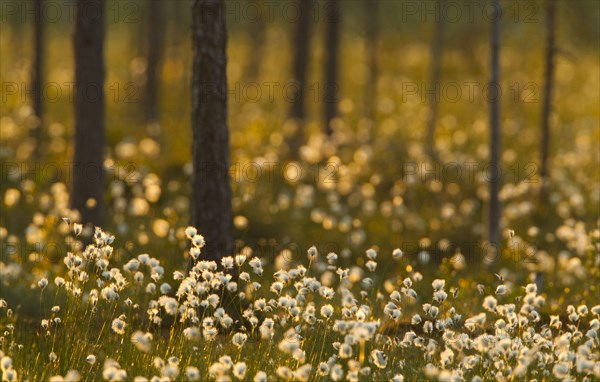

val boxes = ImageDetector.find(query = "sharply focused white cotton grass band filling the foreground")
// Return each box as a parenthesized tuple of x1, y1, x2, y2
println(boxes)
(0, 220, 600, 381)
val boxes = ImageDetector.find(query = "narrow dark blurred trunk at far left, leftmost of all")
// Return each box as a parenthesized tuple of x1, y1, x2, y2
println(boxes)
(30, 0, 44, 159)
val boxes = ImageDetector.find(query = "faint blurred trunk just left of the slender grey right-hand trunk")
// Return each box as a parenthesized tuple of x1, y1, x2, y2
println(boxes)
(427, 1, 444, 157)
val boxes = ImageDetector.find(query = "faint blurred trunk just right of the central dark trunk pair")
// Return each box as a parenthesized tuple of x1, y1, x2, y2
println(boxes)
(364, 0, 379, 120)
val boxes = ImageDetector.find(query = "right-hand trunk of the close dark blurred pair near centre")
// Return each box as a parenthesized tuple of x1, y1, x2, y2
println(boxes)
(323, 0, 340, 136)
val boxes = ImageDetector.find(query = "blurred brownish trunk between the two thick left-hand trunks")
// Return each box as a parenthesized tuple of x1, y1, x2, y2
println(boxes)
(146, 0, 163, 122)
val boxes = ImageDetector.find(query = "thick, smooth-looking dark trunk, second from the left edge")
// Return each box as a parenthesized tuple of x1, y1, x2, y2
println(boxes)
(71, 0, 105, 226)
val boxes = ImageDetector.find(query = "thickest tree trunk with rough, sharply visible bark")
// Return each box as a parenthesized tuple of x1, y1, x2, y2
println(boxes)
(191, 0, 233, 264)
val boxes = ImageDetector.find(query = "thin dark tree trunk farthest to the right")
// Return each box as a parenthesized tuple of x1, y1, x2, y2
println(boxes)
(540, 0, 556, 202)
